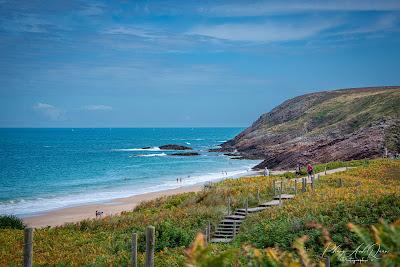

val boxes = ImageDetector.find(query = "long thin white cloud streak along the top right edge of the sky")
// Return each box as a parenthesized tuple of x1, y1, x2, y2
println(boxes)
(205, 0, 400, 17)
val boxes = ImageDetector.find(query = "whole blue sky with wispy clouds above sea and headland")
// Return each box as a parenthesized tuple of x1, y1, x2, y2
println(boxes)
(0, 0, 400, 127)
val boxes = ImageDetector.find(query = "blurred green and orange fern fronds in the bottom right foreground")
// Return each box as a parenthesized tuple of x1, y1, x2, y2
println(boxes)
(187, 220, 400, 267)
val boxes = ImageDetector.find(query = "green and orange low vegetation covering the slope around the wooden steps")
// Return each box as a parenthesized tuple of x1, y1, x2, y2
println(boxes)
(0, 159, 400, 266)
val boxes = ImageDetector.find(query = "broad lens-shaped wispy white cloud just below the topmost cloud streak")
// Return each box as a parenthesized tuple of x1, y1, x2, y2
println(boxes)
(189, 21, 338, 43)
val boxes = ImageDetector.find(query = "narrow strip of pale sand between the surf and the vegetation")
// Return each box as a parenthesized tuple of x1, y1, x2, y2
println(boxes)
(22, 171, 260, 228)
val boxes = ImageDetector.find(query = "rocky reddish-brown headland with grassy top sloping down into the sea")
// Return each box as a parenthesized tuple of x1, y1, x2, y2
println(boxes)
(221, 86, 400, 169)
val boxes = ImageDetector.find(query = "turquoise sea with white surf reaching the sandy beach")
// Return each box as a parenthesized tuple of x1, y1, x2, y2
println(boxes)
(0, 128, 257, 216)
